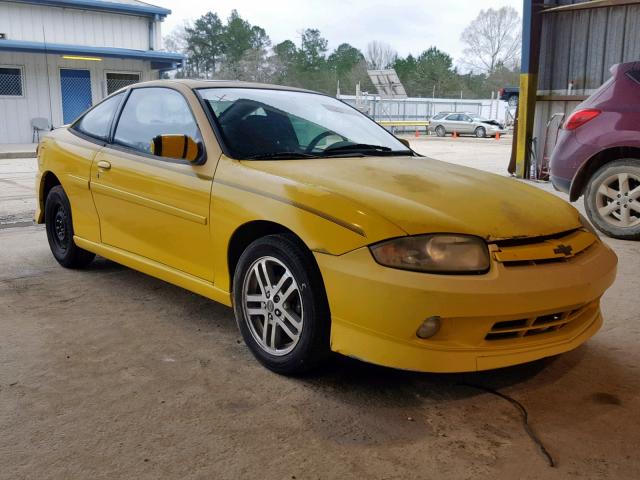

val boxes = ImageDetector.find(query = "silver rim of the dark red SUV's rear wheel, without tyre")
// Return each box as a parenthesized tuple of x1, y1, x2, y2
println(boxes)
(596, 173, 640, 228)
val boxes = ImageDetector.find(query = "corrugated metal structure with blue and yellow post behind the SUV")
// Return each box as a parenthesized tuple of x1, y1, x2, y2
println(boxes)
(515, 0, 640, 178)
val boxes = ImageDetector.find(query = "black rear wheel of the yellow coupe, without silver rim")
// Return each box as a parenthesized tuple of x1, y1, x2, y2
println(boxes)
(44, 185, 95, 268)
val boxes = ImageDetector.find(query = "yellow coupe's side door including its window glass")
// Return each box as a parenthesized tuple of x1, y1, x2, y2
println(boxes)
(91, 87, 213, 281)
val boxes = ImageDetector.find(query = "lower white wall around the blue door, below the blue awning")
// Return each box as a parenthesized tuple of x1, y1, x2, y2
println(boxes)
(0, 52, 159, 143)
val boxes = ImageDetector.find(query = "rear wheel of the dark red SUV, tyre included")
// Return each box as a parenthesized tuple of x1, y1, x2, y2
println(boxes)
(584, 158, 640, 240)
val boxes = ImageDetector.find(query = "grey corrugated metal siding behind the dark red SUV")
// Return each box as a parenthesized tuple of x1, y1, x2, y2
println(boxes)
(533, 0, 640, 172)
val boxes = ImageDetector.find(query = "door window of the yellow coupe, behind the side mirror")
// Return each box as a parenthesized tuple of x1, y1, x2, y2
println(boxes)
(113, 87, 201, 153)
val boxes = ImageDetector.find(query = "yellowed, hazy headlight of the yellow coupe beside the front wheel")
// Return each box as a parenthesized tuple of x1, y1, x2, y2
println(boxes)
(369, 234, 489, 274)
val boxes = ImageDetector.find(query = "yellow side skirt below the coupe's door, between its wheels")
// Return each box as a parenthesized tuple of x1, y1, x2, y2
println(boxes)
(73, 236, 231, 307)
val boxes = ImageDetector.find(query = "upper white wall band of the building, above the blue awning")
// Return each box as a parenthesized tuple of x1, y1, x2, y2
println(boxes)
(0, 2, 149, 50)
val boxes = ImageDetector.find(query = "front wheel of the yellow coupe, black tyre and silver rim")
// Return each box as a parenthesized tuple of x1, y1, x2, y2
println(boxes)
(233, 235, 330, 375)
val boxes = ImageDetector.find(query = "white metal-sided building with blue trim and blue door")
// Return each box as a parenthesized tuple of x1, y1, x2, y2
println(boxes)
(0, 0, 183, 143)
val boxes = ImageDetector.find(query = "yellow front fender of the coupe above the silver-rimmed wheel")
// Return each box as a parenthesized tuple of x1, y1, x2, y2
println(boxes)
(211, 157, 407, 288)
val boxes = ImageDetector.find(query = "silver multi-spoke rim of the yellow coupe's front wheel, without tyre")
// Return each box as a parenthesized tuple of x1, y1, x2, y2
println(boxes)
(242, 256, 304, 356)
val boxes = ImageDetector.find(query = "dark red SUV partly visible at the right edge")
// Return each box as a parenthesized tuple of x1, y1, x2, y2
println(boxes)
(551, 62, 640, 240)
